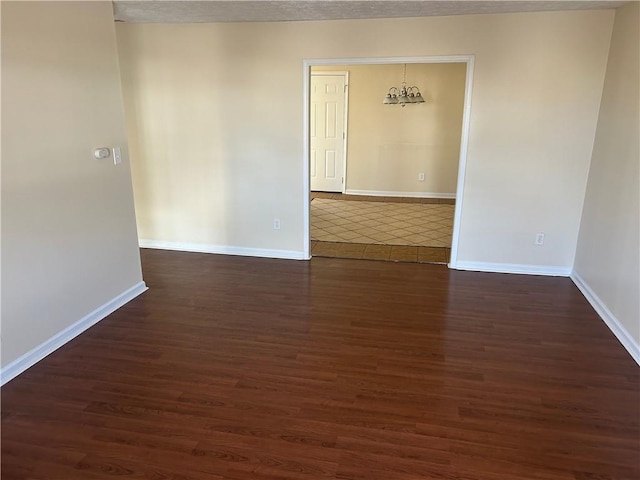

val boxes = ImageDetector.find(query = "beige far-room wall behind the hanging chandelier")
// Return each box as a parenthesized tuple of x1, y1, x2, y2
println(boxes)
(311, 63, 466, 197)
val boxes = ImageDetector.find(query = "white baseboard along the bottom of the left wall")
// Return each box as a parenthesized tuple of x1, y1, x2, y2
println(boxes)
(0, 282, 147, 385)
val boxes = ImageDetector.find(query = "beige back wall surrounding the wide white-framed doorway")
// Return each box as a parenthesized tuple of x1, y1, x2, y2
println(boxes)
(116, 10, 614, 270)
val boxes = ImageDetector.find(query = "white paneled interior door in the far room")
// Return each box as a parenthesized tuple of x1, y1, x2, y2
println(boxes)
(309, 72, 347, 192)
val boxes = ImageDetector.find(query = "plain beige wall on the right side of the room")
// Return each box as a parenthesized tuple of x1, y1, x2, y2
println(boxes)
(574, 2, 640, 345)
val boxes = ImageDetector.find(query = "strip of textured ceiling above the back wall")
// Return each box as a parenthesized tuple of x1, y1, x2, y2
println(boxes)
(113, 0, 627, 23)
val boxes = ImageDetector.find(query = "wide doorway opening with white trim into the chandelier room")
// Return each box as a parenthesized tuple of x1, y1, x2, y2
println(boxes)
(304, 56, 473, 268)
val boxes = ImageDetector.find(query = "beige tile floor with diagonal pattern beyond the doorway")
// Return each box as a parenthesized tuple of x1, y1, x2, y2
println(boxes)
(311, 192, 455, 263)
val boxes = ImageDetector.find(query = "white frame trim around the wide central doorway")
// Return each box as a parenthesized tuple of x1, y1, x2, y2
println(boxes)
(302, 55, 475, 268)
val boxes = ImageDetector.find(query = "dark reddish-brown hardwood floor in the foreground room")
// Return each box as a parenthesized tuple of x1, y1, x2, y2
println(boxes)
(1, 250, 640, 480)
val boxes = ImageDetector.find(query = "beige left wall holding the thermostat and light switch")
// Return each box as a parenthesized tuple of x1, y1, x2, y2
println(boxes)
(1, 2, 142, 367)
